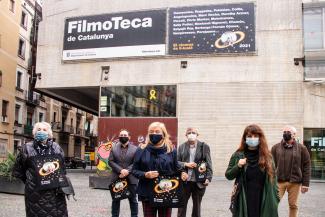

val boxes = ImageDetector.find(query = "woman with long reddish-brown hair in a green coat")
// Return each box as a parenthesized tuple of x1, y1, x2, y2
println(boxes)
(225, 124, 280, 217)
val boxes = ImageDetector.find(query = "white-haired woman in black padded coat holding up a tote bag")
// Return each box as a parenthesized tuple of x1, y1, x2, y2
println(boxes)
(13, 122, 68, 217)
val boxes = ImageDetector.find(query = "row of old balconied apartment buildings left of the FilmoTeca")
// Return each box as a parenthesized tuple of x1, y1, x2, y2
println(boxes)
(0, 0, 97, 159)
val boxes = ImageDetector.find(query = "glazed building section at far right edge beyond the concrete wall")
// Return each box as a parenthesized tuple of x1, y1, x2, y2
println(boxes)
(303, 1, 325, 180)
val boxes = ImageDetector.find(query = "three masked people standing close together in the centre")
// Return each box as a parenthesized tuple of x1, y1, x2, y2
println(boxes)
(109, 122, 212, 217)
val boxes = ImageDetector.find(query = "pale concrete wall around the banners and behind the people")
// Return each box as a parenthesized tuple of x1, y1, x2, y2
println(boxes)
(37, 0, 316, 176)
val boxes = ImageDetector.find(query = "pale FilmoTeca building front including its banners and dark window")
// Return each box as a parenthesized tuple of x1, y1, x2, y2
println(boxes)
(36, 0, 325, 178)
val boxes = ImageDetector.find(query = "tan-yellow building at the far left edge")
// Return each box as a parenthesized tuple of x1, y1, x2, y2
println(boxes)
(0, 0, 22, 159)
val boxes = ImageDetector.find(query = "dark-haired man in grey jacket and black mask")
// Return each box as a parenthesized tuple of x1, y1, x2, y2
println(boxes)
(109, 130, 138, 217)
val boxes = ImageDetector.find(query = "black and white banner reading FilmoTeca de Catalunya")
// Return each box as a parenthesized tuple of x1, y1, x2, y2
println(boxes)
(63, 10, 166, 60)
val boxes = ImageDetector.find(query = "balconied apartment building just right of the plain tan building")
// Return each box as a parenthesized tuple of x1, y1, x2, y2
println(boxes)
(13, 0, 46, 153)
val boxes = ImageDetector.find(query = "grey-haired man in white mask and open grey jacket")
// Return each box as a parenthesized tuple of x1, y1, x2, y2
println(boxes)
(177, 128, 212, 217)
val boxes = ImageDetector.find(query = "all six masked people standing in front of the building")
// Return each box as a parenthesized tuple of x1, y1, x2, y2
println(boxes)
(13, 122, 310, 217)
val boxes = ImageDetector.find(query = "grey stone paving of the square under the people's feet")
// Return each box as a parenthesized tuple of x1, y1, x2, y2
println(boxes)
(0, 170, 325, 217)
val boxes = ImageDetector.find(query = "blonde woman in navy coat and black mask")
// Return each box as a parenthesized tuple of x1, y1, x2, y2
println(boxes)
(132, 122, 187, 217)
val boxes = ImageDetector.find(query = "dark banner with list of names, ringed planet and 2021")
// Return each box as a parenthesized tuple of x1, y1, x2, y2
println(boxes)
(168, 3, 255, 55)
